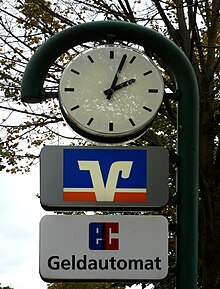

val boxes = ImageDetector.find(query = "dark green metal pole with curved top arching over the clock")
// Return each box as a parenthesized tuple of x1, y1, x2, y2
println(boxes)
(21, 21, 199, 289)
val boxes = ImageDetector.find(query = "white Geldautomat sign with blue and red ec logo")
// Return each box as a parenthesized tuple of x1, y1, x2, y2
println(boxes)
(40, 215, 168, 282)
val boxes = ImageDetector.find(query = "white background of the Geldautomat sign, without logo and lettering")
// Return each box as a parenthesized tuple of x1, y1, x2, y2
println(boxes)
(39, 215, 168, 282)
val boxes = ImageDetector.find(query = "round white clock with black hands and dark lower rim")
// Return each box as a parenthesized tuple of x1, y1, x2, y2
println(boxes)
(59, 45, 164, 144)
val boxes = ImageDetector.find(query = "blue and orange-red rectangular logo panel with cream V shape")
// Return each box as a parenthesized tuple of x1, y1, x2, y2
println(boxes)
(63, 149, 147, 202)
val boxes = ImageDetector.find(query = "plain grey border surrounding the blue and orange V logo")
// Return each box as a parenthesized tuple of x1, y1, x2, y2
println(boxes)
(40, 146, 169, 211)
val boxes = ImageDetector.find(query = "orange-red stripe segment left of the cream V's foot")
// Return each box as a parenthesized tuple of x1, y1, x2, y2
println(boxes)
(63, 192, 96, 202)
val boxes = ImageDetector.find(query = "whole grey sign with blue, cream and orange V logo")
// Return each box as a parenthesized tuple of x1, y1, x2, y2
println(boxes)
(40, 146, 169, 211)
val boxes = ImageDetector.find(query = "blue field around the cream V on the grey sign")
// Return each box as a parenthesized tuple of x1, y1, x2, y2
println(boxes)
(63, 149, 147, 188)
